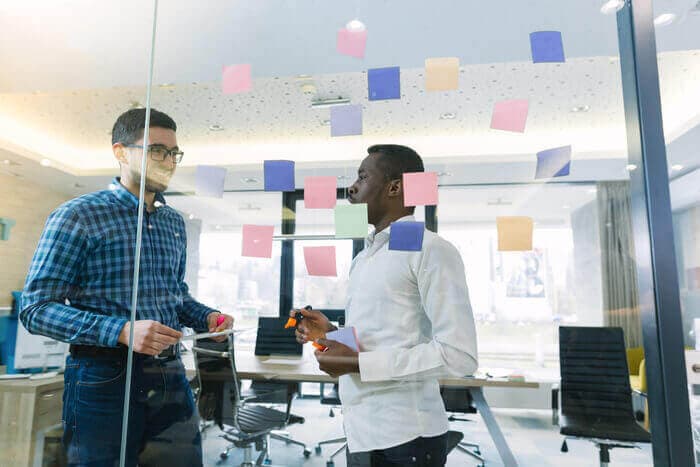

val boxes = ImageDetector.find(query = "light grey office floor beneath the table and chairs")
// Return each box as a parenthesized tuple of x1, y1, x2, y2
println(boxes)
(203, 399, 653, 467)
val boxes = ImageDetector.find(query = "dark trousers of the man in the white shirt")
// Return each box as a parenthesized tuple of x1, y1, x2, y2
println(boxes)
(347, 433, 447, 467)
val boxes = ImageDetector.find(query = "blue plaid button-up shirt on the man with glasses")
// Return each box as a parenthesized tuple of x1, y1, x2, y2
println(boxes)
(20, 179, 215, 347)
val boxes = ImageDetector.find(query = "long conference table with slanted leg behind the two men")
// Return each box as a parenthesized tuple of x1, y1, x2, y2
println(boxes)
(183, 345, 540, 467)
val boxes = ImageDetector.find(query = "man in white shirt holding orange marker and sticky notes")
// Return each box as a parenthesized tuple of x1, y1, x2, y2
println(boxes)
(292, 145, 477, 467)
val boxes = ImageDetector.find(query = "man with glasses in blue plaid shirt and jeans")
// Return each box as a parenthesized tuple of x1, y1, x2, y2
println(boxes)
(20, 109, 233, 466)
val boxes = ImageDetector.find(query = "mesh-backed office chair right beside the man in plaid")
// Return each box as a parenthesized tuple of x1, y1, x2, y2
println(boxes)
(192, 335, 311, 467)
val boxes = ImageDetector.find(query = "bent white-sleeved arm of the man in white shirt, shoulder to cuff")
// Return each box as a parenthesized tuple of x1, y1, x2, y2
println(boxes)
(358, 238, 478, 382)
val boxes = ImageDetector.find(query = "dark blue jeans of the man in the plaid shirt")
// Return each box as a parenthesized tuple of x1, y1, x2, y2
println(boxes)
(63, 354, 202, 467)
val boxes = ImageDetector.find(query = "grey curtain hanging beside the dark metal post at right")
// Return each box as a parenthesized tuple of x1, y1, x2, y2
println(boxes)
(598, 181, 642, 348)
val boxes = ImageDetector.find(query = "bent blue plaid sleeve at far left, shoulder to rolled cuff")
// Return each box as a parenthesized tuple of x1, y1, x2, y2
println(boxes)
(19, 208, 127, 347)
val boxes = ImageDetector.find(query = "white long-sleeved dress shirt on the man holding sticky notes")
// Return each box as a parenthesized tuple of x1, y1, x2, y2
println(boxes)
(339, 216, 477, 452)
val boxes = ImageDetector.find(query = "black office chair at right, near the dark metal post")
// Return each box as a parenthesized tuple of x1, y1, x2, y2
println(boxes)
(559, 326, 651, 467)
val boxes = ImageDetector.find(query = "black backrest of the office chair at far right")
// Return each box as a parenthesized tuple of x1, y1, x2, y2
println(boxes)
(559, 326, 634, 419)
